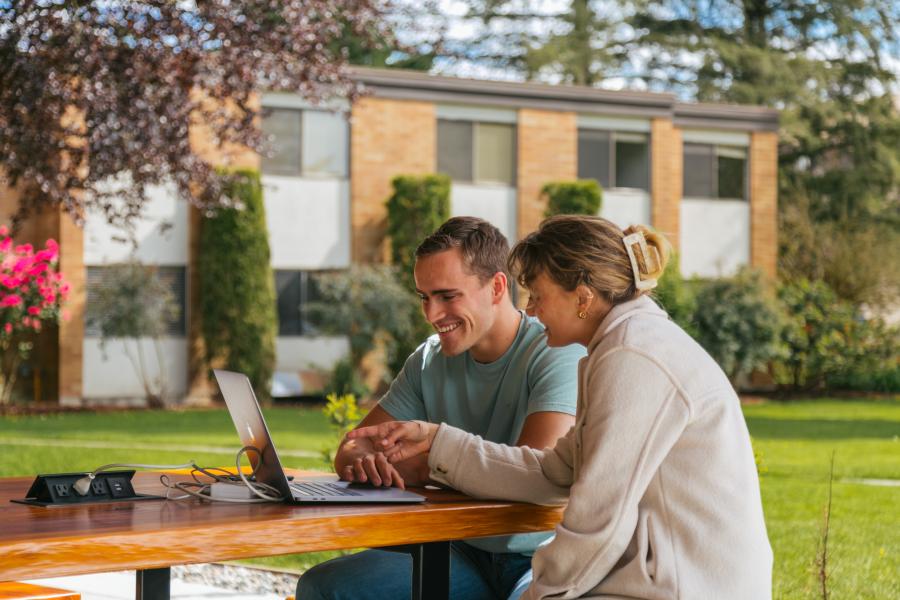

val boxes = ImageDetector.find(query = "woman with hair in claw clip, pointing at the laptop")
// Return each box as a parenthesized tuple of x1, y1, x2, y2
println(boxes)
(349, 216, 772, 599)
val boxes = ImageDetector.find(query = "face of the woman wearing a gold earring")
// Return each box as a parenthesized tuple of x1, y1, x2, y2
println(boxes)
(525, 273, 587, 346)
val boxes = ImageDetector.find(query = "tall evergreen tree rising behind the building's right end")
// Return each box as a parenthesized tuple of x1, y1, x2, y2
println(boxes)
(627, 0, 900, 303)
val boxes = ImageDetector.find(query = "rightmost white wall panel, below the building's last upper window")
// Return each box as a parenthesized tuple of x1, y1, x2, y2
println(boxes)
(680, 198, 750, 277)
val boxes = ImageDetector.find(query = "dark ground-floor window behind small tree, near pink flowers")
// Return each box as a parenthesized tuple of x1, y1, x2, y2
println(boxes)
(84, 265, 187, 337)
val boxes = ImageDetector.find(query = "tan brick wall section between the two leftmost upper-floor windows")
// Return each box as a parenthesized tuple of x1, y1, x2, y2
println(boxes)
(350, 97, 437, 262)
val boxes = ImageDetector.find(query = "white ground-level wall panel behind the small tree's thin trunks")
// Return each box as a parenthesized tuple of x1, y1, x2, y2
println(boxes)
(82, 337, 188, 400)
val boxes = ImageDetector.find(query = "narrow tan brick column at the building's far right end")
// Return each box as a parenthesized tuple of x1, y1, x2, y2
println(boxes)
(750, 131, 778, 278)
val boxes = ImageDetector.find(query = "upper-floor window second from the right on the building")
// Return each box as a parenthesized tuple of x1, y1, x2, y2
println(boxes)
(578, 129, 650, 191)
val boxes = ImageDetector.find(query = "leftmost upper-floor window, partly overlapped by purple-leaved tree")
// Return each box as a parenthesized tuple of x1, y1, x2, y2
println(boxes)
(262, 108, 348, 177)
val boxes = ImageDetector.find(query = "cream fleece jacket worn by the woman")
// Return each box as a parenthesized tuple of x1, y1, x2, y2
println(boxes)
(428, 297, 772, 600)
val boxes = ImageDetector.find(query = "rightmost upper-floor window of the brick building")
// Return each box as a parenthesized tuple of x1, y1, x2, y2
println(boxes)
(684, 144, 747, 200)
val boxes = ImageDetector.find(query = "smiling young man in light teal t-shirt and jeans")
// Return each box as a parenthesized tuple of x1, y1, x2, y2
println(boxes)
(297, 217, 584, 600)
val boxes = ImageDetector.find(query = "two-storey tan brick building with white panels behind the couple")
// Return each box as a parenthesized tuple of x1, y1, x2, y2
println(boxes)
(0, 69, 778, 402)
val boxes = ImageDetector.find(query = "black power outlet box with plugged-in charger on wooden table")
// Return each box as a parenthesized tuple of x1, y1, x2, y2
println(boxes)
(13, 471, 163, 506)
